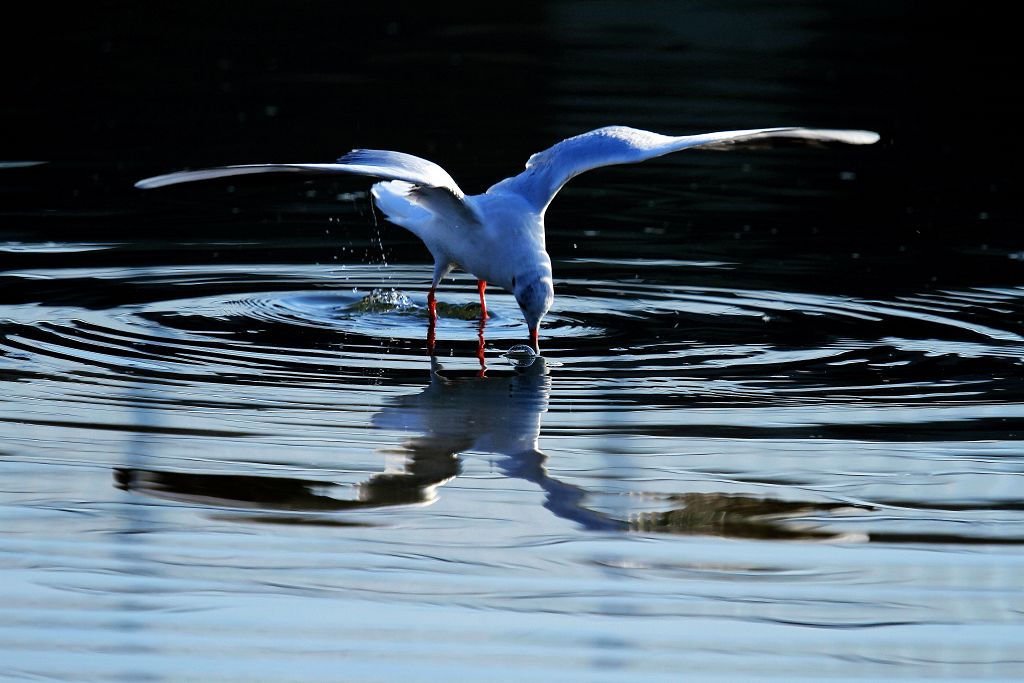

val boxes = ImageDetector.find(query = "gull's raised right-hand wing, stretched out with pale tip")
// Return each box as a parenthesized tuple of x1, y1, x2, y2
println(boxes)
(487, 126, 879, 212)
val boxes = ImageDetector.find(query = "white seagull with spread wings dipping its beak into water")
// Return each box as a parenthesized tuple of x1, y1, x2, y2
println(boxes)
(135, 126, 880, 351)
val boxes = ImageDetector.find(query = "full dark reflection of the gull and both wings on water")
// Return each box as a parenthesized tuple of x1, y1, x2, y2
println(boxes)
(108, 356, 884, 541)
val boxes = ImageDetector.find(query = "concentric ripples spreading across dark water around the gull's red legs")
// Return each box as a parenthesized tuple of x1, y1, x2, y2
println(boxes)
(0, 262, 1024, 399)
